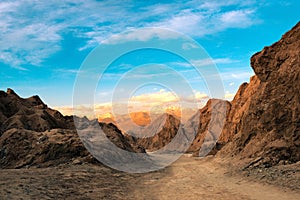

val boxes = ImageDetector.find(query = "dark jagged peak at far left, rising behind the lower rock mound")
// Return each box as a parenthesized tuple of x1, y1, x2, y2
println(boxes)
(0, 89, 73, 133)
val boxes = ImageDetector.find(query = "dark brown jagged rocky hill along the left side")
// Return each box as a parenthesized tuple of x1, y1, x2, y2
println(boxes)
(0, 89, 144, 168)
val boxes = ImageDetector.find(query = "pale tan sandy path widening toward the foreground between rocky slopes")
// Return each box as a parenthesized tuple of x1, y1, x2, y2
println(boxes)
(135, 156, 300, 200)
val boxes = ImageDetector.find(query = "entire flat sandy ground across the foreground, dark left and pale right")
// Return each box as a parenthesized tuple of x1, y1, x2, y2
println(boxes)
(0, 156, 300, 200)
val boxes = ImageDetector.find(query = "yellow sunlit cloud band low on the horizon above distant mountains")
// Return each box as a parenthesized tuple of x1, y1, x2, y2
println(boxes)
(54, 89, 209, 118)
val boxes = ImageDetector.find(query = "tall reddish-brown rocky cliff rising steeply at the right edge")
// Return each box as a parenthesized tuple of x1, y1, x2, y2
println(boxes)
(190, 23, 300, 167)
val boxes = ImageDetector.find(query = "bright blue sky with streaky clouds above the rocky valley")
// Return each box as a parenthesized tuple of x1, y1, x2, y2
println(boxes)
(0, 0, 300, 116)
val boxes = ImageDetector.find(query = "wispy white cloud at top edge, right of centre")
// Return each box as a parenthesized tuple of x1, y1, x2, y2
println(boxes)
(151, 1, 260, 37)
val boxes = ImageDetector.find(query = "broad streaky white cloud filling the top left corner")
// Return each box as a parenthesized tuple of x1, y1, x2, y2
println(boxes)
(0, 0, 127, 68)
